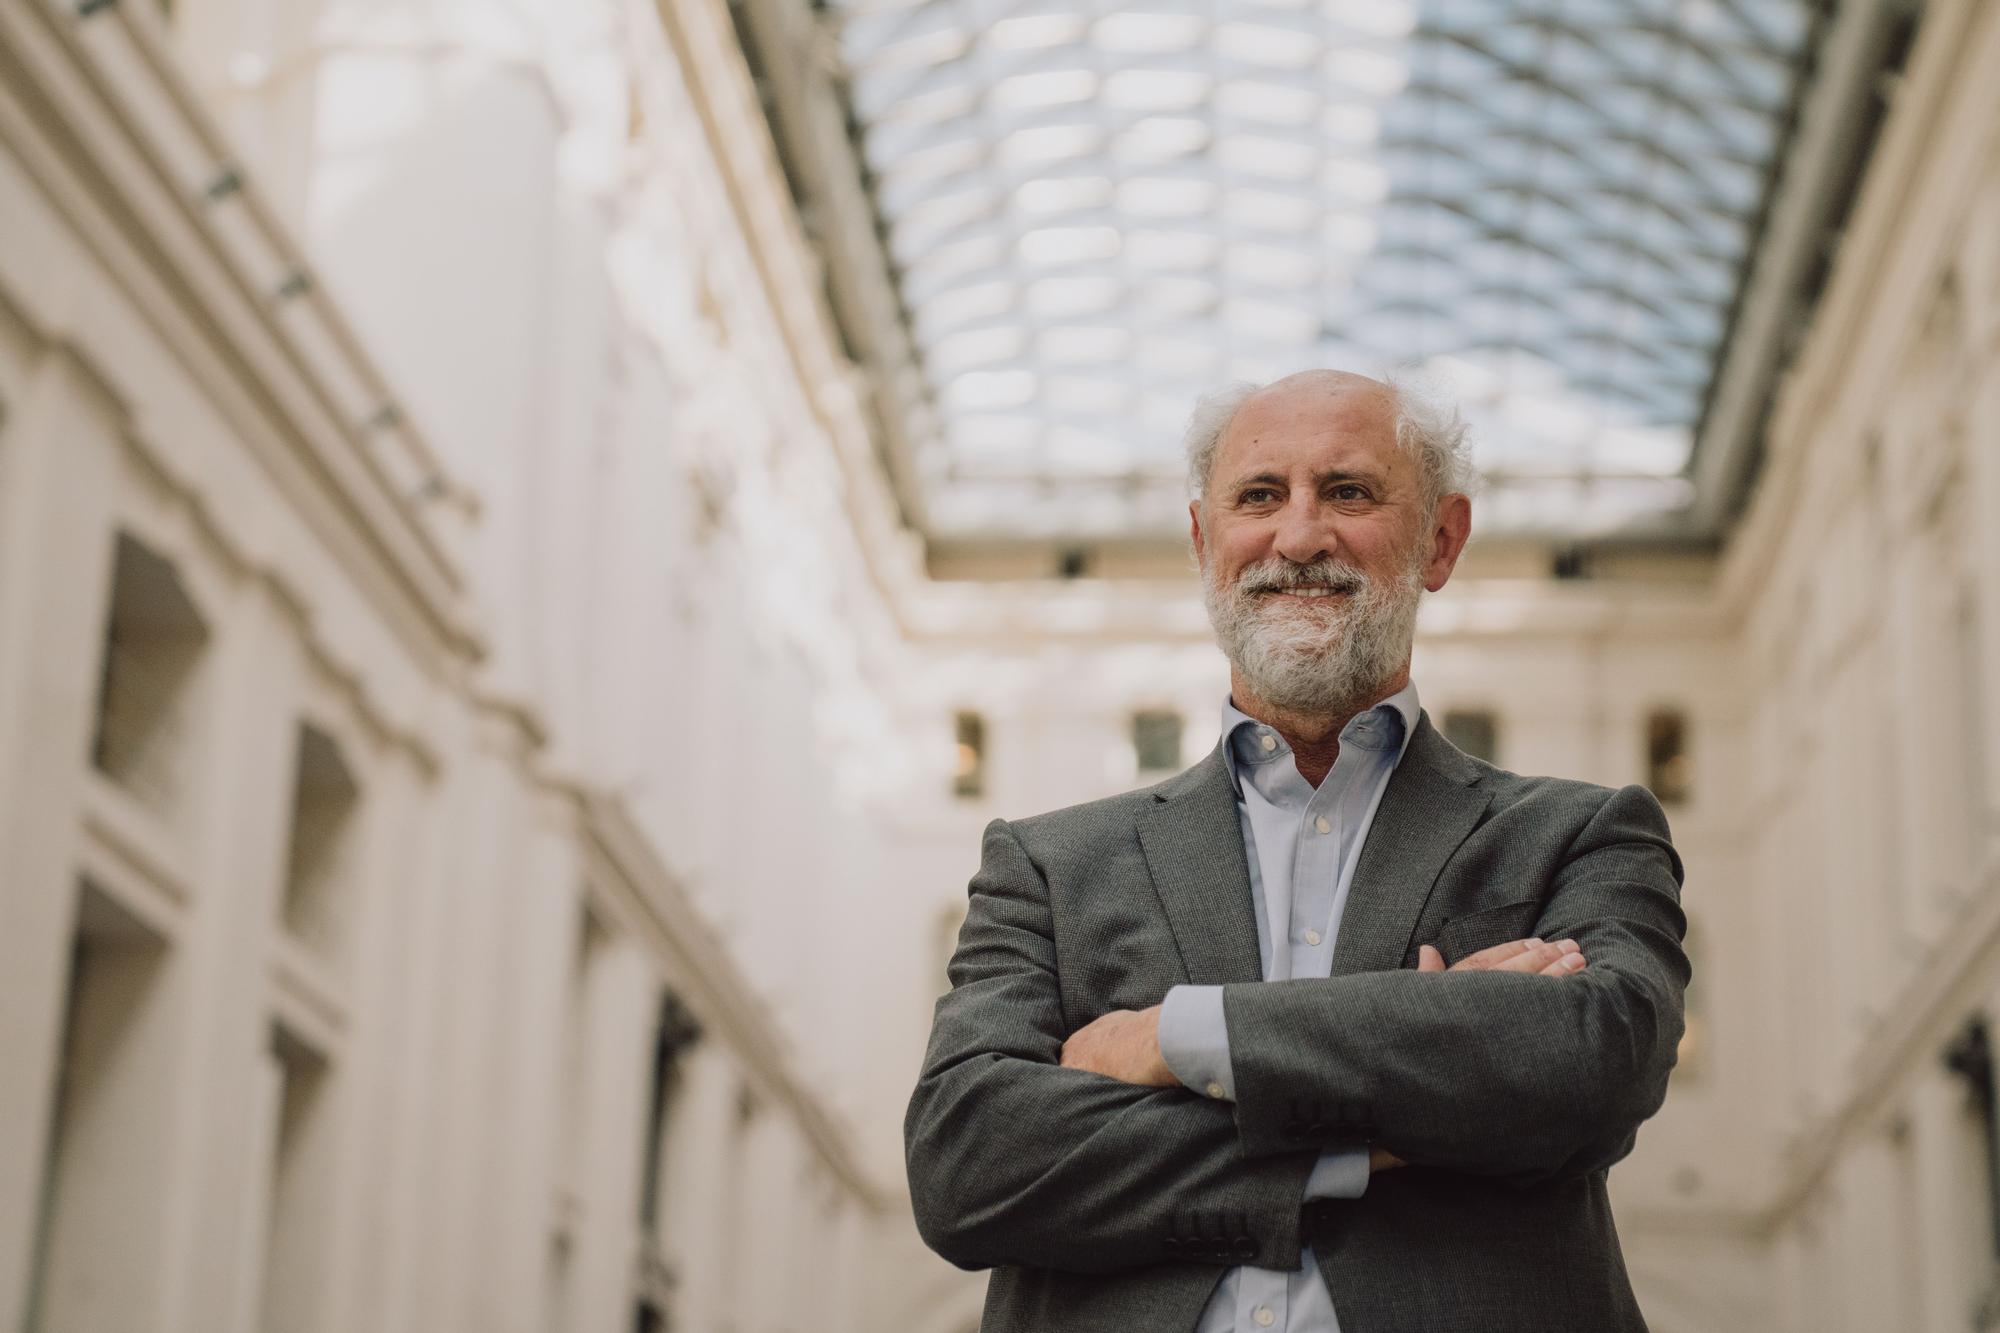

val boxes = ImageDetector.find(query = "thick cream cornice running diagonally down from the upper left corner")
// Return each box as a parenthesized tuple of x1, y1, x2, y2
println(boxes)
(0, 0, 480, 660)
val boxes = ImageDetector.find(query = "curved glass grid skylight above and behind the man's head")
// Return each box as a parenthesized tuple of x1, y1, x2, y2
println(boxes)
(830, 0, 1814, 536)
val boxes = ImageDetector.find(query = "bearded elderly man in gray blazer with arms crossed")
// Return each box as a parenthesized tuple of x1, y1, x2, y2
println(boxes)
(904, 372, 1688, 1333)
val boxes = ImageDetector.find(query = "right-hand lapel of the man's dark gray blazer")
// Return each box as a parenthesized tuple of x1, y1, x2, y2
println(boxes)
(1336, 711, 1492, 977)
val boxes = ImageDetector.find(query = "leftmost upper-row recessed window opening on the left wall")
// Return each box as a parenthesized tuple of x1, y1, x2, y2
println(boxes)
(90, 532, 208, 817)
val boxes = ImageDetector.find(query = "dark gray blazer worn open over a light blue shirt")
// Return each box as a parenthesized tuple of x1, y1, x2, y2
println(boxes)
(904, 713, 1688, 1333)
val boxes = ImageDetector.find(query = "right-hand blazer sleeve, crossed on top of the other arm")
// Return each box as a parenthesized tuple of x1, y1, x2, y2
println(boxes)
(1224, 787, 1688, 1183)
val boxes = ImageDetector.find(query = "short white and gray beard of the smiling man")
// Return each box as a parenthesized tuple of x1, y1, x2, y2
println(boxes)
(1202, 548, 1424, 717)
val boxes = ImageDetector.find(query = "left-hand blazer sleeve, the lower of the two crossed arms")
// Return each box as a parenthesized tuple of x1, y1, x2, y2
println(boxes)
(904, 819, 1318, 1273)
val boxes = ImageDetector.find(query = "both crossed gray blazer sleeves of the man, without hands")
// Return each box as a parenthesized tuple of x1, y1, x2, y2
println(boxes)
(904, 787, 1688, 1273)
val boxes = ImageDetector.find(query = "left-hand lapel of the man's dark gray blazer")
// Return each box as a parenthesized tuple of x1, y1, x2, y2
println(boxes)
(1138, 745, 1264, 985)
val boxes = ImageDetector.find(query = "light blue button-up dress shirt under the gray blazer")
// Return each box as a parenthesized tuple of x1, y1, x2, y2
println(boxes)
(1160, 681, 1418, 1333)
